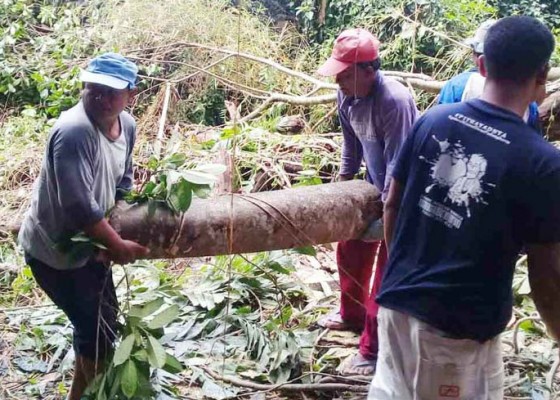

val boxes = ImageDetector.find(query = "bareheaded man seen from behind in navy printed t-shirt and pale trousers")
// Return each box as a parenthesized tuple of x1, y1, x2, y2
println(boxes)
(369, 17, 560, 400)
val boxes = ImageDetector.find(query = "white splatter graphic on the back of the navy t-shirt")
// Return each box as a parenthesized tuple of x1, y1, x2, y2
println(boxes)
(419, 135, 495, 229)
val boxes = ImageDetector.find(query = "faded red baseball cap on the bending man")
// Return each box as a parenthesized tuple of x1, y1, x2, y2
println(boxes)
(317, 28, 380, 76)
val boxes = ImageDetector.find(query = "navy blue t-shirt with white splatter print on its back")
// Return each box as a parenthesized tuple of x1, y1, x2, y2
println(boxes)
(377, 99, 560, 341)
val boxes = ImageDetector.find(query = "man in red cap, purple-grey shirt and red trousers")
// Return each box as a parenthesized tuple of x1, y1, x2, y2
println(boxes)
(318, 29, 418, 375)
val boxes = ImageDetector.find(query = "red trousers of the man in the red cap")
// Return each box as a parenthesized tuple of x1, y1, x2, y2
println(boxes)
(336, 240, 387, 359)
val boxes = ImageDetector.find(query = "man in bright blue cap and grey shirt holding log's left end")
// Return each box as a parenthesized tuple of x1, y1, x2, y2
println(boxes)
(19, 53, 148, 400)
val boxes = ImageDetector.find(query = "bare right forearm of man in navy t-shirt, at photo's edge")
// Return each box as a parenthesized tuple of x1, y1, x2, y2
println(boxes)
(527, 244, 560, 340)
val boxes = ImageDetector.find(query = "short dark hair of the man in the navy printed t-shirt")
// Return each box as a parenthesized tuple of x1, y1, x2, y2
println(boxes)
(484, 16, 554, 82)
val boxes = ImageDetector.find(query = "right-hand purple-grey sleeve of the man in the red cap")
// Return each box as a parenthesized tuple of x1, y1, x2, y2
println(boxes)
(382, 99, 418, 199)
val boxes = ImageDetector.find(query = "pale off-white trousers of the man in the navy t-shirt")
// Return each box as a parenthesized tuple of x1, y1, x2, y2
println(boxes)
(368, 307, 503, 400)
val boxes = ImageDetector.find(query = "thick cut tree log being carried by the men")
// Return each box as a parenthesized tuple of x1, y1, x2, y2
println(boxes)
(110, 181, 380, 258)
